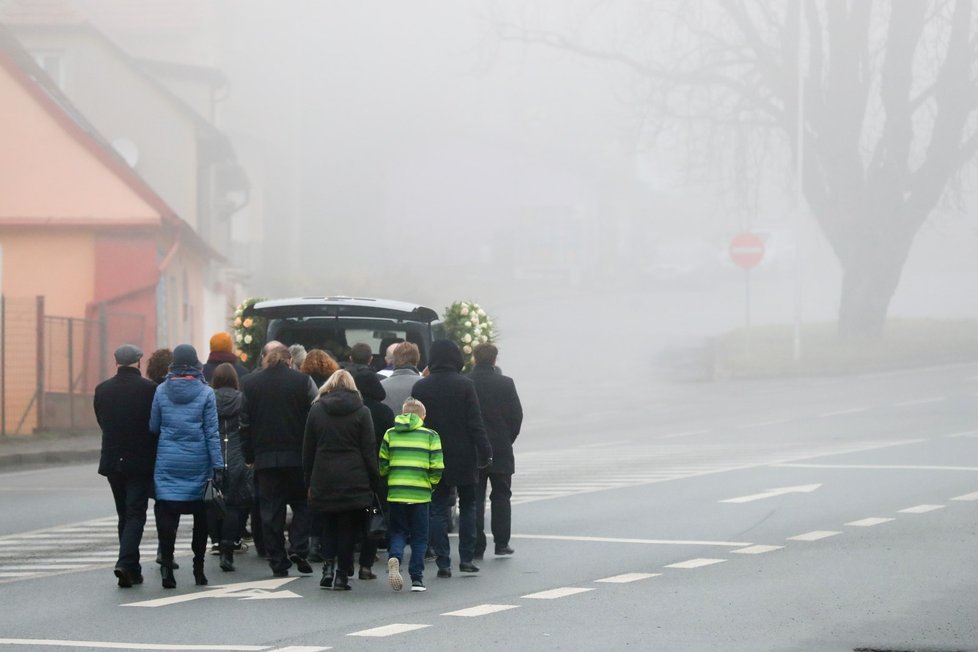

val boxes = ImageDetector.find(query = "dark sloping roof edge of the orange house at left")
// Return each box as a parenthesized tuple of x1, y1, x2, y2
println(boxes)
(0, 25, 223, 260)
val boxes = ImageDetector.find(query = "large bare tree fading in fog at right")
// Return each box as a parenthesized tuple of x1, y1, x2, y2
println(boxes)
(495, 0, 978, 339)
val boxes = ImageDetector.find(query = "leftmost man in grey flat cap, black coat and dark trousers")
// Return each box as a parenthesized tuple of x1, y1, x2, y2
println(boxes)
(94, 344, 157, 588)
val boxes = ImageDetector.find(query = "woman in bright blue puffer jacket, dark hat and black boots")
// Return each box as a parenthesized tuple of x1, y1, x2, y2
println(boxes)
(149, 344, 224, 589)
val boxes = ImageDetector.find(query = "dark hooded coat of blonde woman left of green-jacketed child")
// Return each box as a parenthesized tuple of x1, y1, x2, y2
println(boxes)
(302, 389, 380, 512)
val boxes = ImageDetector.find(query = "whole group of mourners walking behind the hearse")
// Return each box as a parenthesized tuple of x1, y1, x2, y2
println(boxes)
(94, 332, 523, 591)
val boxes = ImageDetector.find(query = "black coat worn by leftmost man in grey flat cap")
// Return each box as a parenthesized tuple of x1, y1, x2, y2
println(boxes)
(93, 367, 158, 477)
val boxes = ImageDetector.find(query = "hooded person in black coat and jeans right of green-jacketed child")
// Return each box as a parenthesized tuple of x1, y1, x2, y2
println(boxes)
(411, 340, 492, 577)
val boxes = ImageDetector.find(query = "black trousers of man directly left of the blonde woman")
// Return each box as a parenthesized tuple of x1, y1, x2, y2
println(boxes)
(255, 466, 309, 571)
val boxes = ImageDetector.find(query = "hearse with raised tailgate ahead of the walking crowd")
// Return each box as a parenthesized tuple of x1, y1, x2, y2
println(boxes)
(245, 296, 445, 369)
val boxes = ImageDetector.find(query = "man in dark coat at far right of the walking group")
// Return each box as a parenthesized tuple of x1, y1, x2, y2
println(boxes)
(469, 343, 523, 558)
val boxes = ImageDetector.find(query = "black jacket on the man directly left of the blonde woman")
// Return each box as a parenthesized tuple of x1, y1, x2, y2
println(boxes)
(241, 363, 315, 469)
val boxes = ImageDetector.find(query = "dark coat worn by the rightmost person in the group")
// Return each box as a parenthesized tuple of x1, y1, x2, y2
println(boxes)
(469, 364, 523, 475)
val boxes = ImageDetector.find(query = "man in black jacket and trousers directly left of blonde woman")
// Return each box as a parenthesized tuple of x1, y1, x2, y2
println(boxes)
(240, 341, 316, 577)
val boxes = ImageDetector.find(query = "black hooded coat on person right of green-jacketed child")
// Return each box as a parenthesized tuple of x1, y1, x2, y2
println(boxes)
(411, 340, 492, 486)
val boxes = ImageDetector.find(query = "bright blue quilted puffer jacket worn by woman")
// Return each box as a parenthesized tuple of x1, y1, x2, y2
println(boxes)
(149, 368, 224, 500)
